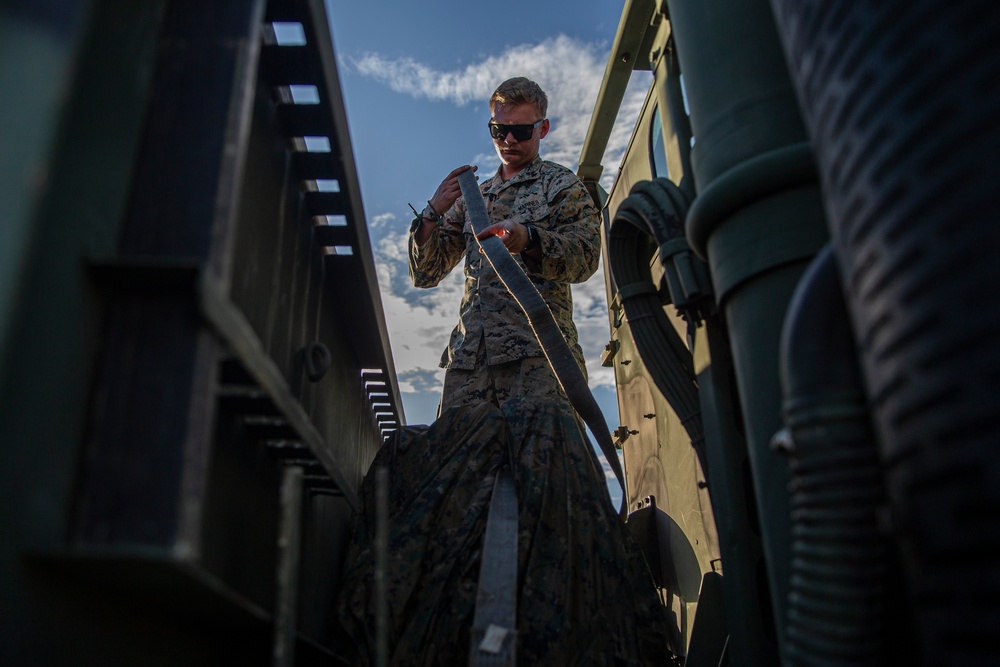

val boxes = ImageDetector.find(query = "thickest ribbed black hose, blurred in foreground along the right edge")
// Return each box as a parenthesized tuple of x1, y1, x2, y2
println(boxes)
(771, 0, 1000, 667)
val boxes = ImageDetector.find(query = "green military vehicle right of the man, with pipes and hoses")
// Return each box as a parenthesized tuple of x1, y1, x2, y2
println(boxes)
(578, 0, 1000, 665)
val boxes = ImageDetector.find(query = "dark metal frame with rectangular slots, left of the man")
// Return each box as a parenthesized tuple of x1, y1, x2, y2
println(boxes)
(0, 0, 405, 665)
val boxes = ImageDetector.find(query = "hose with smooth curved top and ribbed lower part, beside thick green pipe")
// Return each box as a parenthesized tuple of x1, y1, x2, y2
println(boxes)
(776, 246, 888, 667)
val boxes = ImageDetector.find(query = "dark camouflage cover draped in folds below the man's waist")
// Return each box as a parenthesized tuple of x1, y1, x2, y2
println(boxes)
(338, 399, 670, 667)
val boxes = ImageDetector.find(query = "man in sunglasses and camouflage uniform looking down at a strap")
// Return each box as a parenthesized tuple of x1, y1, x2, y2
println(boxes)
(409, 77, 601, 412)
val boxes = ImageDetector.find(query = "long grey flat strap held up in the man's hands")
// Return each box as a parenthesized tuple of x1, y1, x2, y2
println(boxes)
(458, 169, 627, 519)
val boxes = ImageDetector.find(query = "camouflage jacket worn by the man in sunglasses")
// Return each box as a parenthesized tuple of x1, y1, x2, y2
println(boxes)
(409, 158, 601, 370)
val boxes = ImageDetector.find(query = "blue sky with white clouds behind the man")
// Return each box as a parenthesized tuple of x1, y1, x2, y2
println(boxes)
(326, 0, 649, 472)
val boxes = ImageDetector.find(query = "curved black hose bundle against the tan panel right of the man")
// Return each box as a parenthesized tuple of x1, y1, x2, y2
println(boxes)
(608, 179, 707, 460)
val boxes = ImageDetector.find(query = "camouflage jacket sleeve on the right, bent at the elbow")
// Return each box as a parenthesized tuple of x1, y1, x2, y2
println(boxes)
(522, 175, 601, 283)
